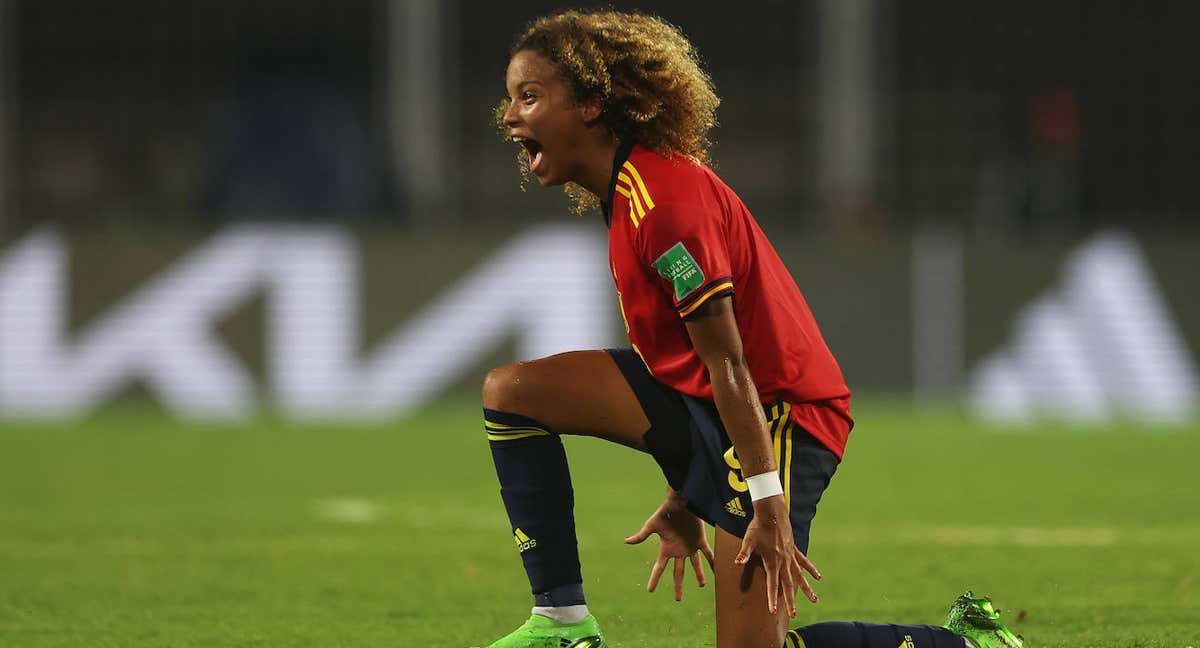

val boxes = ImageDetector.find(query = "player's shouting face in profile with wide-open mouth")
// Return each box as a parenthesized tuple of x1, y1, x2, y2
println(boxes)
(504, 50, 589, 186)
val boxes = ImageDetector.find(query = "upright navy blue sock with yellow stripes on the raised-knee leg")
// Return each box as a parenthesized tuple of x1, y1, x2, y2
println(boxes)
(484, 408, 583, 604)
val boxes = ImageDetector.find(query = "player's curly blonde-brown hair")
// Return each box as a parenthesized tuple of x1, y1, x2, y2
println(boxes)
(496, 11, 721, 209)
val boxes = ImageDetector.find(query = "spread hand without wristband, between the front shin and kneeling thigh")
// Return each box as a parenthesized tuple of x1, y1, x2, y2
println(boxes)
(625, 491, 715, 601)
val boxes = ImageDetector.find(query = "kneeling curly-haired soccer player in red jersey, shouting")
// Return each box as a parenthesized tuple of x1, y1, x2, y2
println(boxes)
(472, 12, 1020, 648)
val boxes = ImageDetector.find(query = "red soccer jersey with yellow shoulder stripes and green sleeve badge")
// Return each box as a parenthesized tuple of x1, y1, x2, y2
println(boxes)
(605, 146, 853, 457)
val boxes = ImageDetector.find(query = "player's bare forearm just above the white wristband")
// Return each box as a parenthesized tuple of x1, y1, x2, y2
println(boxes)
(708, 355, 778, 476)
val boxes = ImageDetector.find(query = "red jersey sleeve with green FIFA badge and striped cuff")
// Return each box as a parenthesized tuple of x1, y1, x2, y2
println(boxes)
(635, 200, 733, 319)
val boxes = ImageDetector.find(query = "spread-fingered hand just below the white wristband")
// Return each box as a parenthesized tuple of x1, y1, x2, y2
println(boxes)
(733, 494, 821, 619)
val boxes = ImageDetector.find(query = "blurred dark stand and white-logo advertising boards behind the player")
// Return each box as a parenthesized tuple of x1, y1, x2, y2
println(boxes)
(0, 0, 1200, 424)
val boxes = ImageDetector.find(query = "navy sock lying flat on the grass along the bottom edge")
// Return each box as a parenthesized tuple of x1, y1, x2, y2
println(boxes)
(784, 622, 966, 648)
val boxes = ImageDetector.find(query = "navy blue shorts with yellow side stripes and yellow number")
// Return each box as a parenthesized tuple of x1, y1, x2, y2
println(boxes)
(608, 349, 839, 553)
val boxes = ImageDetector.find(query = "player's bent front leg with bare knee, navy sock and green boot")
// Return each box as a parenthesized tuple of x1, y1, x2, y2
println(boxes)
(482, 350, 649, 648)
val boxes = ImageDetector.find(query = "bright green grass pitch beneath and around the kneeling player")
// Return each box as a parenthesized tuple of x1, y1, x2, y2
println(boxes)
(0, 398, 1200, 648)
